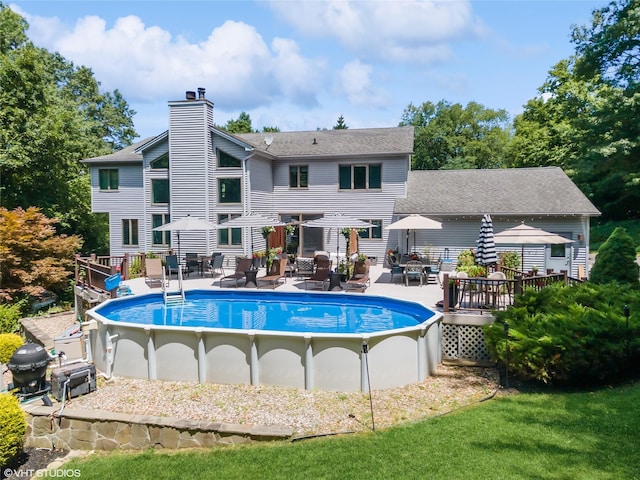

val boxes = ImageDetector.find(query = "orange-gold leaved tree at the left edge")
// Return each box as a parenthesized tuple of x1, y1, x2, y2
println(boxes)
(0, 207, 82, 302)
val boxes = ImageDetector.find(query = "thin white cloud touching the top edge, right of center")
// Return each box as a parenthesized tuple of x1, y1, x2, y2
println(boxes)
(270, 0, 485, 63)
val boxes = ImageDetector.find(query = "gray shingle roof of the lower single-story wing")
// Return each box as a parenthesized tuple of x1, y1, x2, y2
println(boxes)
(394, 167, 600, 216)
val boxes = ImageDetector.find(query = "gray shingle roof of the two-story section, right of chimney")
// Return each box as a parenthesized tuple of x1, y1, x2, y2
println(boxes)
(235, 127, 413, 157)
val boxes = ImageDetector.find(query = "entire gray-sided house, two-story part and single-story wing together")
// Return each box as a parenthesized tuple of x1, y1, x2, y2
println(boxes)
(84, 89, 598, 278)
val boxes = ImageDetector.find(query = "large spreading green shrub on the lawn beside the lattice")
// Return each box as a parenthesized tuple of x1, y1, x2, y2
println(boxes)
(485, 283, 640, 385)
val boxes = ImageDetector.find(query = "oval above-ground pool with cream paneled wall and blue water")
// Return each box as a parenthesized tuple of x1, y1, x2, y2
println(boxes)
(87, 290, 441, 391)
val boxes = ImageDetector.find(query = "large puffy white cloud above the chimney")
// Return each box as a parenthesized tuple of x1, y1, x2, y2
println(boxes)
(16, 7, 326, 109)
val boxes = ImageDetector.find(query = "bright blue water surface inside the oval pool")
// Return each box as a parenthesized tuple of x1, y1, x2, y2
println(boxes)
(96, 290, 435, 333)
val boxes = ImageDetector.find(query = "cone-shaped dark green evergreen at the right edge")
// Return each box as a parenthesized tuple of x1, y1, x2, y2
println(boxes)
(589, 227, 640, 285)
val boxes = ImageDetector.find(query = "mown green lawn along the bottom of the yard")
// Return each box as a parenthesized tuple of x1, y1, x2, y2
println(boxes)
(64, 383, 640, 480)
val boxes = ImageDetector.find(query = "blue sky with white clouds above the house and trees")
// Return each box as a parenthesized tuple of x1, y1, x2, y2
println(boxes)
(12, 0, 608, 141)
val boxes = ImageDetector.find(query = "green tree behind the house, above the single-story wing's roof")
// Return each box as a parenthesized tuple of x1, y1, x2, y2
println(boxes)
(400, 100, 511, 170)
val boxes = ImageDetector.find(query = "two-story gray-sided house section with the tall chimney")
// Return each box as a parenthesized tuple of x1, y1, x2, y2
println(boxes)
(85, 89, 413, 264)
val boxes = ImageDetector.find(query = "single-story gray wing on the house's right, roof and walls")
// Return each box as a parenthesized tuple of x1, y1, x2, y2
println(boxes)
(391, 167, 600, 276)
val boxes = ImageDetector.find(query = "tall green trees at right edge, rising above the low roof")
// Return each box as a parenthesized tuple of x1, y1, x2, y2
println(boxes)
(509, 0, 640, 221)
